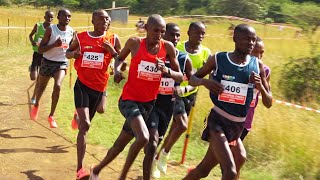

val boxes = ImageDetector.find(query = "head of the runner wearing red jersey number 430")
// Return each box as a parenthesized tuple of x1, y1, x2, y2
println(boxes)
(145, 14, 166, 44)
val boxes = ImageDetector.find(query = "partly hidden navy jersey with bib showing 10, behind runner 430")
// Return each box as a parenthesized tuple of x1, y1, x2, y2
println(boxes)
(158, 50, 187, 95)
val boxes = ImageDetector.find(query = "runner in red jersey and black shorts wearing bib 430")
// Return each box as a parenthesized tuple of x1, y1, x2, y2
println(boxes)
(91, 14, 183, 180)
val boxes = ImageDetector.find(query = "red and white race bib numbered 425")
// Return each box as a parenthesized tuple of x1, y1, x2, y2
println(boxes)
(81, 52, 104, 69)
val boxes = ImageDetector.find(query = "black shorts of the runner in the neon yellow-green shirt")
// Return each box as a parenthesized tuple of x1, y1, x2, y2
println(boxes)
(173, 93, 197, 116)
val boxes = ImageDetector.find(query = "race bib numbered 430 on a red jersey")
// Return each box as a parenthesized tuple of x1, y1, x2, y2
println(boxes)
(138, 60, 161, 81)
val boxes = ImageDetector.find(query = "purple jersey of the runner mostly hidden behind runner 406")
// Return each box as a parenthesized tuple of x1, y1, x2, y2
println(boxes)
(244, 65, 271, 130)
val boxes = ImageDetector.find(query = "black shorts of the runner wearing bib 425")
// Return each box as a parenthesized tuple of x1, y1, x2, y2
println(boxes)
(73, 79, 103, 121)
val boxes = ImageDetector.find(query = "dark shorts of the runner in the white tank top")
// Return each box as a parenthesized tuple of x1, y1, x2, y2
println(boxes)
(40, 58, 68, 77)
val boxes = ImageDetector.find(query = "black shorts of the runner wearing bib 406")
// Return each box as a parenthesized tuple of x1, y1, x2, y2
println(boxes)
(201, 109, 244, 143)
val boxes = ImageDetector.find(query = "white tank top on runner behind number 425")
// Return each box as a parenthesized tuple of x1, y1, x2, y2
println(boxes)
(43, 24, 74, 62)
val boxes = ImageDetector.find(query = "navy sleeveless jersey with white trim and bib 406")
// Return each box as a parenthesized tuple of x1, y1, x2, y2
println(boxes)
(210, 52, 259, 118)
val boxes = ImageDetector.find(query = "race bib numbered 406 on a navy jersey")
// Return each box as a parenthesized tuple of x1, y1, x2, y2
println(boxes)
(218, 80, 248, 105)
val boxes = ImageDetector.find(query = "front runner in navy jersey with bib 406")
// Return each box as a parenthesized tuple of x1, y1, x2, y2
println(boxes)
(184, 24, 268, 180)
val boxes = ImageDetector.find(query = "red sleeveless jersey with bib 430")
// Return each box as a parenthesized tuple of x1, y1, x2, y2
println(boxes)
(122, 38, 167, 102)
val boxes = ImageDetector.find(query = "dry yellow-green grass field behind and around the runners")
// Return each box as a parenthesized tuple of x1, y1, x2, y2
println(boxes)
(0, 7, 320, 180)
